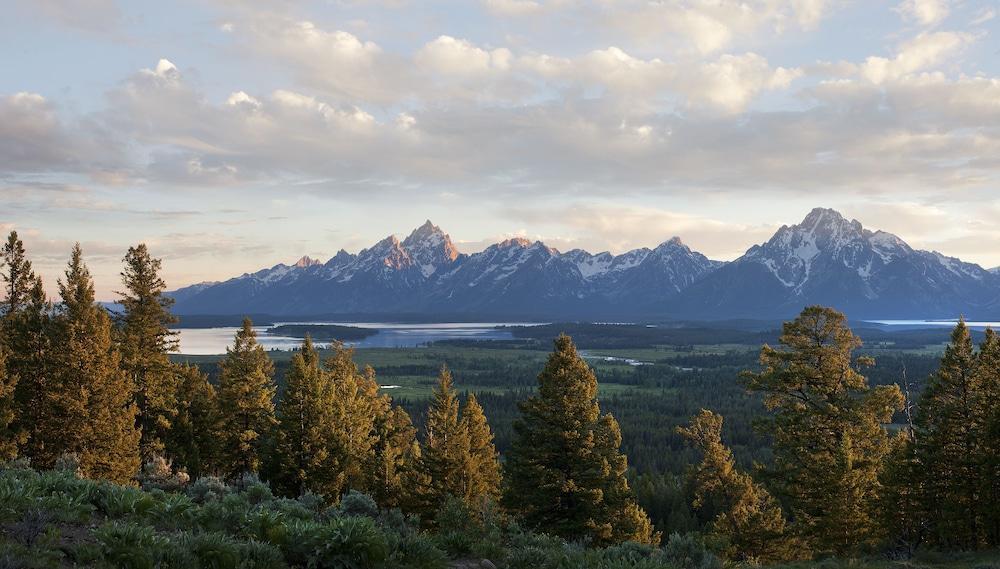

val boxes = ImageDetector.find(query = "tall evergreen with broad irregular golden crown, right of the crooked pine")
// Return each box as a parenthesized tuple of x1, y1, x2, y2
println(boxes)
(745, 306, 902, 553)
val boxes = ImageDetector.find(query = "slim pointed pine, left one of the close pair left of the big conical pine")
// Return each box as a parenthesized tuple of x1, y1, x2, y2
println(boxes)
(421, 366, 470, 514)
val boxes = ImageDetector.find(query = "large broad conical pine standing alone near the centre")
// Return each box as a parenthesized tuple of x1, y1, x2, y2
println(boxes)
(504, 335, 659, 545)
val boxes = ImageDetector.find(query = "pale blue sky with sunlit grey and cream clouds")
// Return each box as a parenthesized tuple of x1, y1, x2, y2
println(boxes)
(0, 0, 1000, 300)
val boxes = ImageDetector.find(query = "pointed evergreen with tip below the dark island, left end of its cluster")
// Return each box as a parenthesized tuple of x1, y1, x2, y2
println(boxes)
(271, 336, 340, 496)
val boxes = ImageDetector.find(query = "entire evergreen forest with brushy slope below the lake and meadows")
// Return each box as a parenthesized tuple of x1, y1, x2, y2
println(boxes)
(0, 233, 1000, 569)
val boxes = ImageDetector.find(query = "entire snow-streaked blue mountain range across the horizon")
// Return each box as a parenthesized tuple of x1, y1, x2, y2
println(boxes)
(170, 208, 1000, 321)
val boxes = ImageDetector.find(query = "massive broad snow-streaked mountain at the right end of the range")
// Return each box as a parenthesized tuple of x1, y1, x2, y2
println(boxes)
(666, 208, 1000, 318)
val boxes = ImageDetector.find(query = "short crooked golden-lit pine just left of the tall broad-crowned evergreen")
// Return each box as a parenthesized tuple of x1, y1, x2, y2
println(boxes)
(677, 409, 795, 563)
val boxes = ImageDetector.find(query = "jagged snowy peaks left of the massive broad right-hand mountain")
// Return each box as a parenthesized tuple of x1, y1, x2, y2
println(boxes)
(171, 221, 720, 318)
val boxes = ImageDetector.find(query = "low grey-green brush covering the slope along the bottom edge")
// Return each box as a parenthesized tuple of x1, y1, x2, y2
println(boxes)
(0, 464, 1000, 569)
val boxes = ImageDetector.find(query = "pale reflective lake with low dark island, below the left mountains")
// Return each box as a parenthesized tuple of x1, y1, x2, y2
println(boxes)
(174, 322, 534, 356)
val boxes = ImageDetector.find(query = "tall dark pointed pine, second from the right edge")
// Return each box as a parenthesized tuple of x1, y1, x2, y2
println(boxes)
(915, 320, 985, 549)
